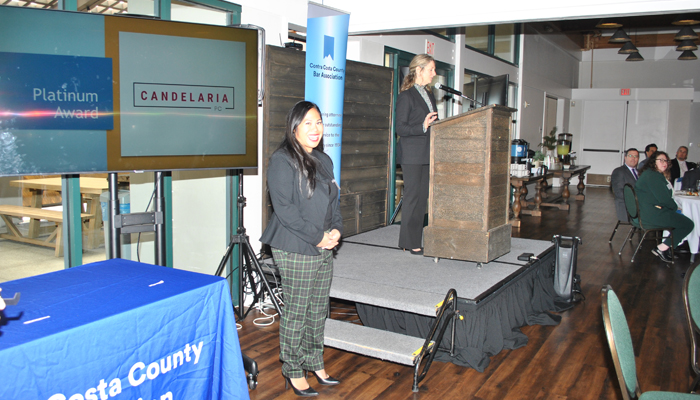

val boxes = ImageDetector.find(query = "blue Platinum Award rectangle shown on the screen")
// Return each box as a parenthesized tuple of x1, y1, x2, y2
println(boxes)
(0, 52, 114, 130)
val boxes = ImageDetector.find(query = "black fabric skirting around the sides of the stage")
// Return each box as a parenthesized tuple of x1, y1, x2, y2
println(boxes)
(356, 248, 561, 372)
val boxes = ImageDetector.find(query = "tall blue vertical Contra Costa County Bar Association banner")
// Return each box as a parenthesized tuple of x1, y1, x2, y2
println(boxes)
(305, 3, 350, 185)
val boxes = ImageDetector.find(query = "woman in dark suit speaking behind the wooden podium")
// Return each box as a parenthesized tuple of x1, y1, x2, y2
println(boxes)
(396, 54, 437, 255)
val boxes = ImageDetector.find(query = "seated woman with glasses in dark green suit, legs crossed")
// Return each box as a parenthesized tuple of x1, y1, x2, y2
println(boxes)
(635, 151, 695, 263)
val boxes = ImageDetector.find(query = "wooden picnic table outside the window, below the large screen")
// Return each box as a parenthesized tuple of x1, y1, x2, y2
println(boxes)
(10, 177, 109, 249)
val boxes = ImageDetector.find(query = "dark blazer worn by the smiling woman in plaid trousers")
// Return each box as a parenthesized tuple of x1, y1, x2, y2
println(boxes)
(260, 149, 343, 256)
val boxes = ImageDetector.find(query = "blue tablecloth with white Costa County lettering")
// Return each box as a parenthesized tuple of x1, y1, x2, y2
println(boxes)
(0, 259, 249, 400)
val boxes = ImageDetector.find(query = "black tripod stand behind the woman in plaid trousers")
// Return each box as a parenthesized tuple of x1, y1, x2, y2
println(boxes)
(216, 169, 282, 320)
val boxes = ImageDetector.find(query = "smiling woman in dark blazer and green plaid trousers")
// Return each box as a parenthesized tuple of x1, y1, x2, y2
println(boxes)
(260, 101, 343, 396)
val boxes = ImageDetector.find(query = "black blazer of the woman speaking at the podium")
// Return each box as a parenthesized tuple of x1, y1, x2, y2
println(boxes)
(396, 86, 437, 164)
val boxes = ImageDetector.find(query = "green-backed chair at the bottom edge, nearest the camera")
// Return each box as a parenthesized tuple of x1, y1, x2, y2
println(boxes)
(601, 285, 700, 400)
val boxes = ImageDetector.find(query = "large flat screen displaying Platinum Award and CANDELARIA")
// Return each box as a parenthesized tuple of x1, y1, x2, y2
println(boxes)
(0, 6, 258, 176)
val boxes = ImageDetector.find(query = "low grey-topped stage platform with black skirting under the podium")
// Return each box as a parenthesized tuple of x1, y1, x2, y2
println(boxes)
(330, 225, 560, 371)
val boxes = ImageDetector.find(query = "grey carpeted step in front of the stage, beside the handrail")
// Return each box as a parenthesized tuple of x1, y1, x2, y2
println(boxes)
(323, 318, 432, 366)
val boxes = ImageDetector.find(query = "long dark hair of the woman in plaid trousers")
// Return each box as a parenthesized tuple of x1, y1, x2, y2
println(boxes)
(279, 101, 323, 198)
